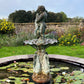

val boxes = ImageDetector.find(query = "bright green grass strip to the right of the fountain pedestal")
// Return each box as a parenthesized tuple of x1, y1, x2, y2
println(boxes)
(47, 45, 84, 58)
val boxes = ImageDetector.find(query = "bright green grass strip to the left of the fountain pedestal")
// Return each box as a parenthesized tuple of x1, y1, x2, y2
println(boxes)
(0, 46, 35, 58)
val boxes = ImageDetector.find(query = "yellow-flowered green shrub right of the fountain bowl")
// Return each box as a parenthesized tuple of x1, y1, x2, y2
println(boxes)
(58, 34, 80, 46)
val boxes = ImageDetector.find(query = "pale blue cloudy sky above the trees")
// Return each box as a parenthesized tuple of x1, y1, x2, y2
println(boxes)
(0, 0, 84, 19)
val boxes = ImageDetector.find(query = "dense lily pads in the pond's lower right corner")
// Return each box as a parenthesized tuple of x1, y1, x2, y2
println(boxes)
(54, 71, 84, 84)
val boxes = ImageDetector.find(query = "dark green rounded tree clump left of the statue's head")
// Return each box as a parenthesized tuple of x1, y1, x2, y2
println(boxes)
(8, 10, 35, 23)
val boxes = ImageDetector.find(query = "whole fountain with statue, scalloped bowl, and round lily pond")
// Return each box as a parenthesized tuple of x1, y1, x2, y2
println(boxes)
(0, 6, 84, 84)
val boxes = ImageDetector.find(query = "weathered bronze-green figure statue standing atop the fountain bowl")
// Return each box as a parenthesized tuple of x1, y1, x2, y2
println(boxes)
(35, 6, 47, 39)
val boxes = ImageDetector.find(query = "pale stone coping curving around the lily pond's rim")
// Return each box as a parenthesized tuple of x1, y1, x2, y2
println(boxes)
(0, 54, 84, 67)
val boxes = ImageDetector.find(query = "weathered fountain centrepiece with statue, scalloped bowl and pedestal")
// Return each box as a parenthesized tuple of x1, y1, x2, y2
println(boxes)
(24, 6, 57, 83)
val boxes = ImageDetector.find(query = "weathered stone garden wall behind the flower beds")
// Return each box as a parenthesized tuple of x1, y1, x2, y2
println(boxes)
(15, 23, 79, 34)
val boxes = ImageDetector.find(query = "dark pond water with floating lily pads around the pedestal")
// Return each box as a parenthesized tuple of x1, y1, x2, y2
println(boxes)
(0, 60, 84, 84)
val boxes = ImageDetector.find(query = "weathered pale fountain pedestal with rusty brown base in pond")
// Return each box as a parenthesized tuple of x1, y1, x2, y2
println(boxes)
(32, 43, 51, 83)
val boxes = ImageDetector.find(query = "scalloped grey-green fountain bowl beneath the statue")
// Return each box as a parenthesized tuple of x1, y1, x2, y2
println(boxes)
(24, 39, 58, 50)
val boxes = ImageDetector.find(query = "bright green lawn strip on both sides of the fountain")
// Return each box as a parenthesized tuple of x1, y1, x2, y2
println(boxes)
(0, 45, 84, 58)
